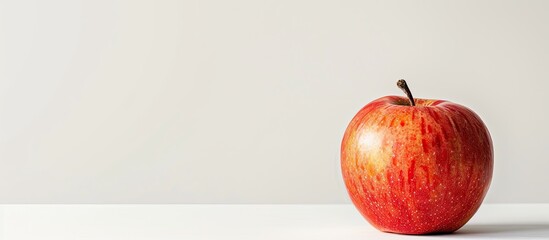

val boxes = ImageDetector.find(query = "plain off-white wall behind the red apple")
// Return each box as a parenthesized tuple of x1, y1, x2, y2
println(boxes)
(0, 0, 549, 203)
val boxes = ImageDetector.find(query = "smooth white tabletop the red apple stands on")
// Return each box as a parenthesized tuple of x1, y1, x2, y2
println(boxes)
(0, 204, 549, 240)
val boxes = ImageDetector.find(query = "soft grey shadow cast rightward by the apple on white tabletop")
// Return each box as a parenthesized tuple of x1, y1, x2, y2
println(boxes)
(448, 223, 549, 239)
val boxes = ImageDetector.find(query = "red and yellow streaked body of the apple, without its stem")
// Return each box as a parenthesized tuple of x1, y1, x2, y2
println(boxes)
(341, 96, 494, 234)
